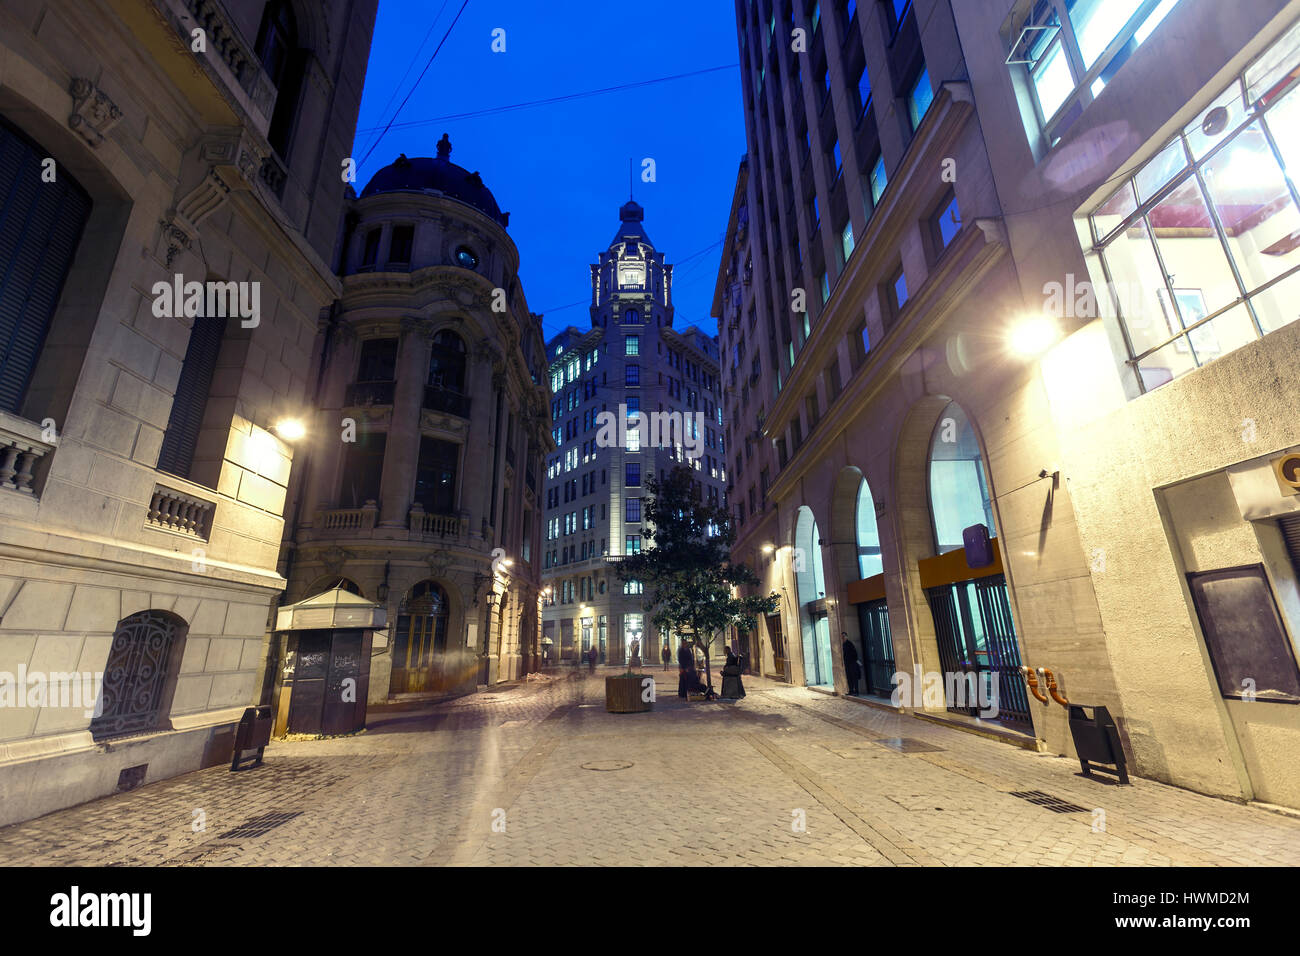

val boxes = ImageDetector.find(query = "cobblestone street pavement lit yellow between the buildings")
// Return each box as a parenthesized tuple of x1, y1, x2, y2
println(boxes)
(0, 670, 1300, 866)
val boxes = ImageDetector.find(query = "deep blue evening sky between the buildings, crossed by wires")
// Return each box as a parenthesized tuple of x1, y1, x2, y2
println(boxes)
(354, 0, 745, 338)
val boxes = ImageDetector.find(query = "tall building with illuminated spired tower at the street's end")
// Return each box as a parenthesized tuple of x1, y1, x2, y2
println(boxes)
(542, 200, 727, 663)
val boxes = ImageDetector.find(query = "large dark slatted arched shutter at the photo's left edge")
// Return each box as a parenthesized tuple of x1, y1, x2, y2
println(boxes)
(0, 121, 91, 414)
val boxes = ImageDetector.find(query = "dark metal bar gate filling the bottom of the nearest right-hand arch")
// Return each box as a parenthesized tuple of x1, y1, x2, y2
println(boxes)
(926, 575, 1030, 723)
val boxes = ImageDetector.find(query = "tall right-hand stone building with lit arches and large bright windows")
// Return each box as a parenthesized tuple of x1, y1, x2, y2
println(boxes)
(715, 0, 1300, 806)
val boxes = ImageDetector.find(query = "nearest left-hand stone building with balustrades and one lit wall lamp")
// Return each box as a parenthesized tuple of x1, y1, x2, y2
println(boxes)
(0, 0, 376, 823)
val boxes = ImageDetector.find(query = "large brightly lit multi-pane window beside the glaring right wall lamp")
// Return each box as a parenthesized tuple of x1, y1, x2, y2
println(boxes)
(1091, 21, 1300, 390)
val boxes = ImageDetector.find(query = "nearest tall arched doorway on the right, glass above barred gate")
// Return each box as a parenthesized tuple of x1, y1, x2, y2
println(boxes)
(922, 402, 1030, 723)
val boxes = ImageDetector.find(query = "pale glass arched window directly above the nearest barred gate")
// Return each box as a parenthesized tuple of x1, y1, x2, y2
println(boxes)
(930, 402, 997, 554)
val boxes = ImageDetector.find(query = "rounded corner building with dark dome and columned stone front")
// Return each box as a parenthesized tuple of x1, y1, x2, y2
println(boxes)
(278, 135, 553, 713)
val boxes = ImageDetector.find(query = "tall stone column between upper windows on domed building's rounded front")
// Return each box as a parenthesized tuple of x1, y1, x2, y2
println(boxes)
(380, 319, 429, 528)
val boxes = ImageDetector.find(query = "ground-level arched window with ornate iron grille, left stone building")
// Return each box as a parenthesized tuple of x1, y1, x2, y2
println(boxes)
(90, 610, 187, 740)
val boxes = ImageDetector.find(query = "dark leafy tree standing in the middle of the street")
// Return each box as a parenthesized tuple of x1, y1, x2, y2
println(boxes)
(615, 464, 779, 688)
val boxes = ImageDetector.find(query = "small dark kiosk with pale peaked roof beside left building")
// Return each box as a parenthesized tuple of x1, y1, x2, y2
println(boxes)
(274, 588, 387, 736)
